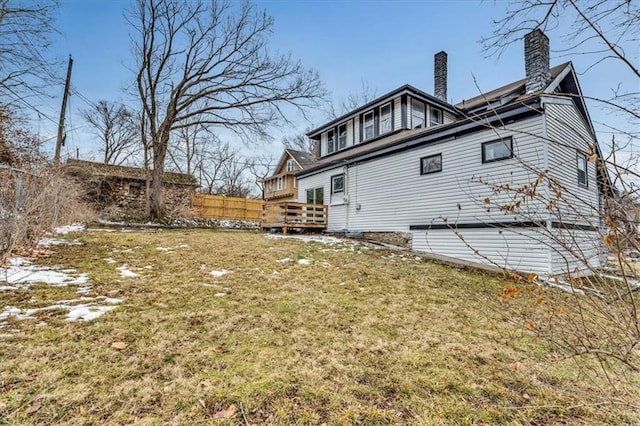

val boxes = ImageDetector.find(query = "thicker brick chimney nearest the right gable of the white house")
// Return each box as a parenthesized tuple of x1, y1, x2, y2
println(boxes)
(524, 29, 551, 93)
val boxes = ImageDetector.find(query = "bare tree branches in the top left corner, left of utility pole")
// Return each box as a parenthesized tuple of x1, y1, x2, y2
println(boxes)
(0, 0, 60, 102)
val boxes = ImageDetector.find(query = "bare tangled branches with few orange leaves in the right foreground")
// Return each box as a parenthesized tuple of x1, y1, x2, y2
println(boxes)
(458, 0, 640, 390)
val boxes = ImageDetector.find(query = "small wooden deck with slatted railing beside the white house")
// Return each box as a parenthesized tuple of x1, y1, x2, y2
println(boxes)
(262, 201, 328, 234)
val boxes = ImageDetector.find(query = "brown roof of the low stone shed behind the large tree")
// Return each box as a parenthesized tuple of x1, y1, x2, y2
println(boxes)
(64, 159, 200, 187)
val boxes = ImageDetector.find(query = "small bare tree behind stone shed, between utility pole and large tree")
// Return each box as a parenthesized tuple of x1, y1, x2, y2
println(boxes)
(81, 100, 139, 164)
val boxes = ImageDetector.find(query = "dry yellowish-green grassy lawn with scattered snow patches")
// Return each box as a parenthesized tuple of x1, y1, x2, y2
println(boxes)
(0, 231, 640, 425)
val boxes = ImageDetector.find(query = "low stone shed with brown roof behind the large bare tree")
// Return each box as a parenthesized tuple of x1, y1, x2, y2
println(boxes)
(64, 159, 199, 218)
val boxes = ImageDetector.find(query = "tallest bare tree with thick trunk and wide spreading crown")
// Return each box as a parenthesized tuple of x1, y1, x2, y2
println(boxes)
(129, 0, 324, 218)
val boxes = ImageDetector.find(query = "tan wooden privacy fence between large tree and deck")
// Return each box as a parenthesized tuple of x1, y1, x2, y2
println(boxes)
(191, 194, 264, 222)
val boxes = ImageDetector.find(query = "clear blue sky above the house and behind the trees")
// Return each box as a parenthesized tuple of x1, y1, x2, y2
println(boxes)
(32, 0, 637, 163)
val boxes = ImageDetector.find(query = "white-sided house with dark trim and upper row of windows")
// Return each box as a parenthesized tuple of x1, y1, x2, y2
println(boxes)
(298, 31, 605, 276)
